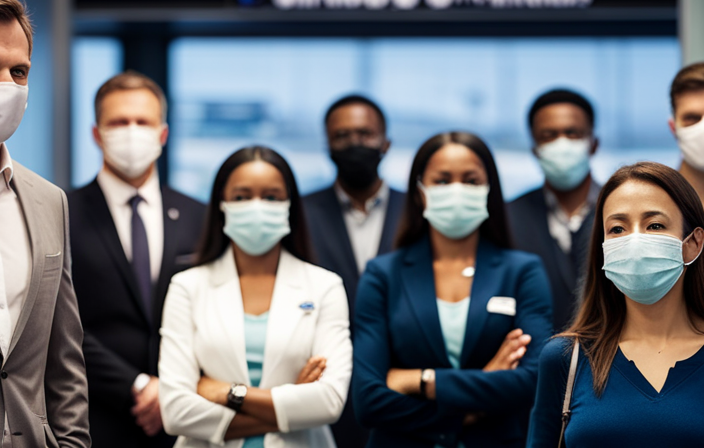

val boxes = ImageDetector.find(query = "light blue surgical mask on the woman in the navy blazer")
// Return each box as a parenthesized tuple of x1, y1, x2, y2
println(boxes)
(418, 182, 489, 240)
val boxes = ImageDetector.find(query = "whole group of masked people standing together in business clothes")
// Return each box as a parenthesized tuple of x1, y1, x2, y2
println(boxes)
(0, 0, 704, 448)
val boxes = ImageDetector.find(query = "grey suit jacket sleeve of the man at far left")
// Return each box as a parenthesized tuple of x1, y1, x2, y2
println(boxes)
(44, 191, 91, 448)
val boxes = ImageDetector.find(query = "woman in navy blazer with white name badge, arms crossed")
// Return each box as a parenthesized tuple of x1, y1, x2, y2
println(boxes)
(352, 132, 552, 448)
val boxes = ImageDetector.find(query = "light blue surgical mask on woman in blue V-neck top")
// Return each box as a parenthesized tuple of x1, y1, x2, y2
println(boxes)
(602, 233, 699, 305)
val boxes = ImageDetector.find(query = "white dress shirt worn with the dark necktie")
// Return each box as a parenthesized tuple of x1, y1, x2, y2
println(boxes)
(98, 167, 164, 282)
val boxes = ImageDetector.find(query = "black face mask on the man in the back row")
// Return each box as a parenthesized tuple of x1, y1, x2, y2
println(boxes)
(330, 145, 381, 191)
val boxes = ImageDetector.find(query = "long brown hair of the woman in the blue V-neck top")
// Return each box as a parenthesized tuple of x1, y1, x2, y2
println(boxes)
(559, 162, 704, 394)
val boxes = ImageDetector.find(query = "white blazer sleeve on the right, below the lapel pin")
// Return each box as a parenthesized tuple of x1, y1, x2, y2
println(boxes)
(271, 280, 352, 432)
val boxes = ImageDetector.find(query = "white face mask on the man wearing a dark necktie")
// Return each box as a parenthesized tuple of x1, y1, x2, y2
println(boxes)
(100, 124, 163, 179)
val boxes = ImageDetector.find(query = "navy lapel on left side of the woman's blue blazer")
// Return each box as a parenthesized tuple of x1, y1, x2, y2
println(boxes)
(401, 238, 450, 367)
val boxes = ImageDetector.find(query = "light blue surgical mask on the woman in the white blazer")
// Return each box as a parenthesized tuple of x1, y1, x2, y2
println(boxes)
(220, 199, 291, 256)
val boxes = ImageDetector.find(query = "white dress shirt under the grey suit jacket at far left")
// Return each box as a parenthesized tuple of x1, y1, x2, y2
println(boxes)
(0, 143, 32, 362)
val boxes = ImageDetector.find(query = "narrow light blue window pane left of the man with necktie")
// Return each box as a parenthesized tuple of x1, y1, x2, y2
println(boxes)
(71, 37, 122, 187)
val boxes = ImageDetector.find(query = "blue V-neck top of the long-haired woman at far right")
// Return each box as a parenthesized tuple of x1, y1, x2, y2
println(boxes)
(528, 338, 704, 448)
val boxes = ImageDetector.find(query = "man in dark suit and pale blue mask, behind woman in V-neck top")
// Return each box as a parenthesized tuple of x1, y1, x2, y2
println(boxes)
(508, 89, 600, 331)
